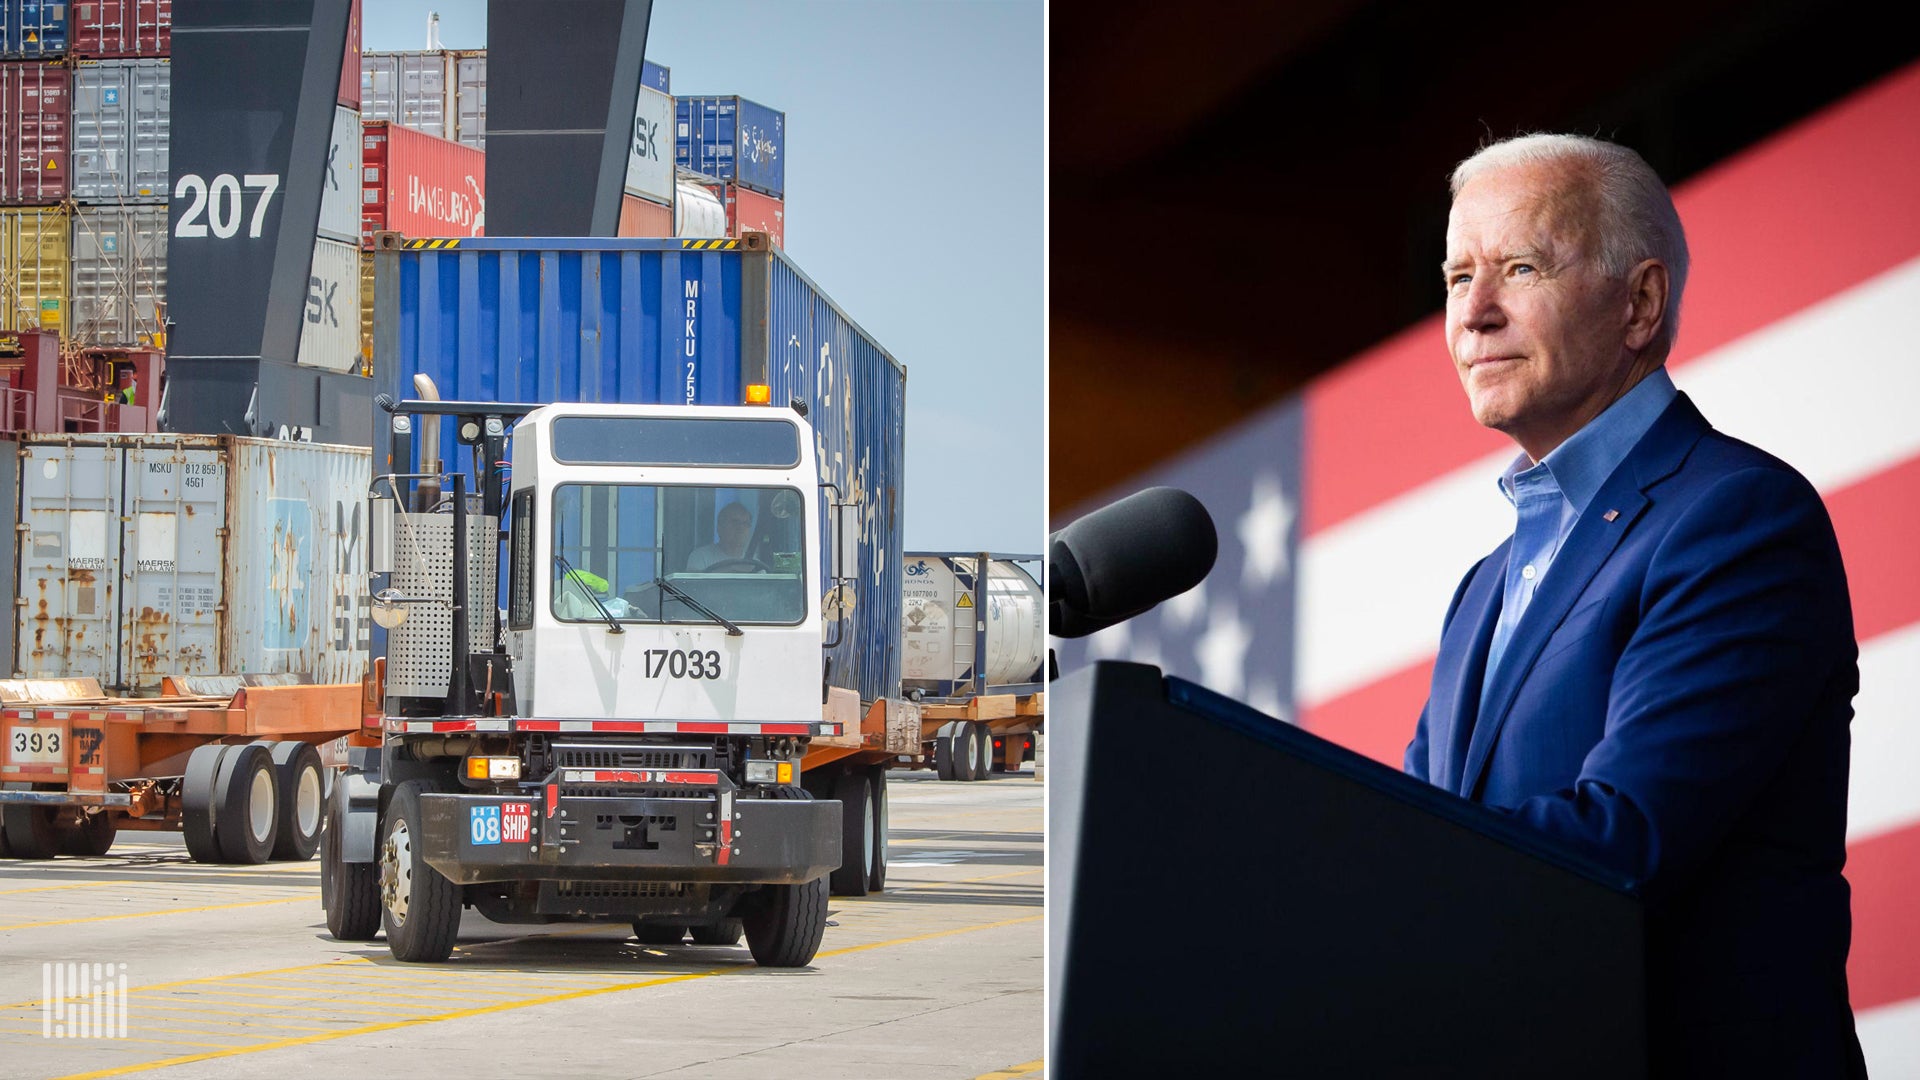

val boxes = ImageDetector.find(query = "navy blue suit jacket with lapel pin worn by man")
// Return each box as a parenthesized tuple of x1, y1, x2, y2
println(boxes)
(1405, 394, 1864, 1076)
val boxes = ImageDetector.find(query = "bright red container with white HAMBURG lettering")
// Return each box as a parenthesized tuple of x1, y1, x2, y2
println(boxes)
(361, 121, 486, 250)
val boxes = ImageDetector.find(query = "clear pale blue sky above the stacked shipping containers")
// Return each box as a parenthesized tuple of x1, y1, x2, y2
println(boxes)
(363, 0, 1046, 553)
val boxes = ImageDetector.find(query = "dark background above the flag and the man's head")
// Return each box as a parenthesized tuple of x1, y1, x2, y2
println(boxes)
(1048, 0, 1920, 513)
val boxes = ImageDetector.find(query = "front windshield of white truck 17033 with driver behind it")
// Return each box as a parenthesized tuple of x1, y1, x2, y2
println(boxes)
(551, 484, 806, 625)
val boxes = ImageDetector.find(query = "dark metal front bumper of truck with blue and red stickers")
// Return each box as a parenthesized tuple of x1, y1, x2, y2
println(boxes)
(420, 794, 841, 884)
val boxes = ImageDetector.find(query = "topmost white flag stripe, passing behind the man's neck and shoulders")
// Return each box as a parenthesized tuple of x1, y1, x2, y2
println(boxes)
(1294, 251, 1920, 707)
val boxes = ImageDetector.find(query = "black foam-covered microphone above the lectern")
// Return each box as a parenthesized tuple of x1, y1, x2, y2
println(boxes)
(1046, 488, 1219, 638)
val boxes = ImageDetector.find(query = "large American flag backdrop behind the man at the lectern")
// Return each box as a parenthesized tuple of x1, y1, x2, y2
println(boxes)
(1052, 65, 1920, 1078)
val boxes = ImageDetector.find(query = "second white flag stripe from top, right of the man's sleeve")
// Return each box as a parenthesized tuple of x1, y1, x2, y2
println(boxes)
(1847, 623, 1920, 844)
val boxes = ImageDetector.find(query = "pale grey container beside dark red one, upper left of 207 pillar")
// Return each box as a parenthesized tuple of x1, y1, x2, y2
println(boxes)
(73, 58, 173, 202)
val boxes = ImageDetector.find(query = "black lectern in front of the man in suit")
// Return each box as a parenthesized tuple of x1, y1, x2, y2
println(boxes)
(1046, 663, 1647, 1080)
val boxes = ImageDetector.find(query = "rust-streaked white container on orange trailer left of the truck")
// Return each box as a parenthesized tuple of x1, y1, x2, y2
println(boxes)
(8, 434, 371, 696)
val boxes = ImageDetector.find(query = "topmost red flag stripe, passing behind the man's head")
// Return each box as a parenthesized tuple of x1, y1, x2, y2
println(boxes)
(1302, 65, 1920, 534)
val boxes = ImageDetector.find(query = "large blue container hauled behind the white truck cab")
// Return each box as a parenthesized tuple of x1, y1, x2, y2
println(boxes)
(374, 236, 906, 701)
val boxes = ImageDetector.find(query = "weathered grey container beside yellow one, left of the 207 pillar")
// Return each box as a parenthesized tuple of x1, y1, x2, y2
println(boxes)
(67, 206, 167, 348)
